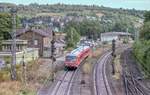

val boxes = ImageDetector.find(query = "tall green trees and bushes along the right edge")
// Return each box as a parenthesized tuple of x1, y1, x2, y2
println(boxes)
(134, 12, 150, 77)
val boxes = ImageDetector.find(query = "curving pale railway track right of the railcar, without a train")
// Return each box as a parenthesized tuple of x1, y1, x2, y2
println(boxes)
(93, 52, 112, 95)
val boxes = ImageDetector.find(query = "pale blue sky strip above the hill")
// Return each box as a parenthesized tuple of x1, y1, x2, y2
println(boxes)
(0, 0, 150, 10)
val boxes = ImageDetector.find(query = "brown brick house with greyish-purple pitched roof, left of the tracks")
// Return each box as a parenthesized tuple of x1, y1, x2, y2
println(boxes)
(16, 28, 52, 57)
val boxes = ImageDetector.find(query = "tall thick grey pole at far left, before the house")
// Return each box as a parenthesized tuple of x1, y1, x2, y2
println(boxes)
(11, 8, 17, 80)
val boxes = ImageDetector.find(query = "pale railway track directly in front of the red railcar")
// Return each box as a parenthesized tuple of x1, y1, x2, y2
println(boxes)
(46, 61, 85, 95)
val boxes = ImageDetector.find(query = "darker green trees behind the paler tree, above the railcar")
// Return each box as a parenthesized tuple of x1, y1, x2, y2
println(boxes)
(65, 20, 103, 40)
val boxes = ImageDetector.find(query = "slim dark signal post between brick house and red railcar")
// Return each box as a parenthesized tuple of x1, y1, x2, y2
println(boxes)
(51, 31, 56, 82)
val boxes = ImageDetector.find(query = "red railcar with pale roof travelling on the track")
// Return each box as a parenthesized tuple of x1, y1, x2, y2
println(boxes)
(65, 46, 91, 68)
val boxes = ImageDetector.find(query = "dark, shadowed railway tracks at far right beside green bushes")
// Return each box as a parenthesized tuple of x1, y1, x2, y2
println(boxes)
(123, 49, 150, 95)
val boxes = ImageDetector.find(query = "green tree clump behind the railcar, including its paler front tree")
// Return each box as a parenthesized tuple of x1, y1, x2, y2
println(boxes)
(64, 20, 102, 47)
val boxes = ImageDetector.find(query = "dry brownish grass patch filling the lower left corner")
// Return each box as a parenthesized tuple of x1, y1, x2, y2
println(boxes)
(0, 58, 53, 95)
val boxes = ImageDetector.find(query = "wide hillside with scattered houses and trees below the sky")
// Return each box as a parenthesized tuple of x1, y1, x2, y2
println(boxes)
(0, 3, 145, 34)
